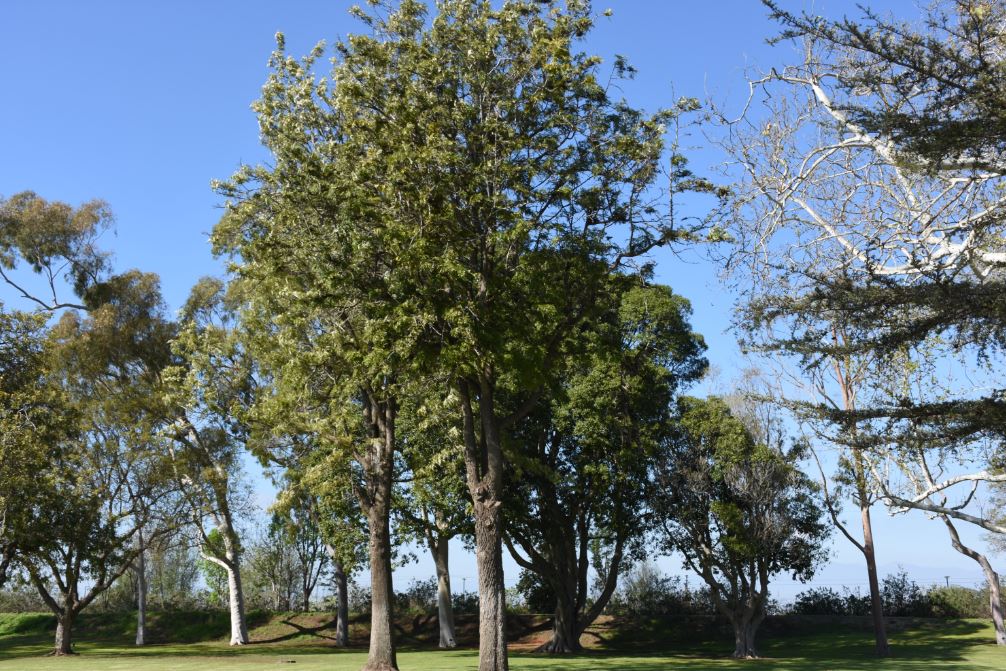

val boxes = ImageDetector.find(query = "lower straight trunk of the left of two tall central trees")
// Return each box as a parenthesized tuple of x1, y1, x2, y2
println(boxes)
(363, 496, 398, 671)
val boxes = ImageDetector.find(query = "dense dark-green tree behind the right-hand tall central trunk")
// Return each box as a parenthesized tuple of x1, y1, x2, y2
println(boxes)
(504, 277, 706, 653)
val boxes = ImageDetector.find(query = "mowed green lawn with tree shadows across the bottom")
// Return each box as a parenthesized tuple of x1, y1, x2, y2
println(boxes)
(0, 616, 1006, 671)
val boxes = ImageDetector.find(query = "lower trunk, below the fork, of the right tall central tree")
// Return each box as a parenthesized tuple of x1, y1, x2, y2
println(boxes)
(475, 497, 509, 671)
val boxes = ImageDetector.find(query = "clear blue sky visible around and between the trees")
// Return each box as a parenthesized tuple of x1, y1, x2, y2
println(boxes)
(0, 0, 1006, 599)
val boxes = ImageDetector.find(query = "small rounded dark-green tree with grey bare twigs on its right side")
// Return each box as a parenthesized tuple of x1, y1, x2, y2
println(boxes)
(655, 396, 828, 658)
